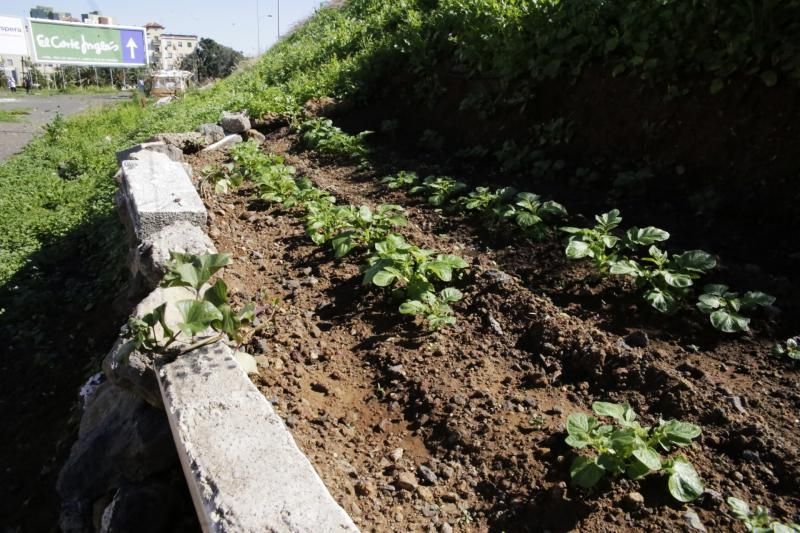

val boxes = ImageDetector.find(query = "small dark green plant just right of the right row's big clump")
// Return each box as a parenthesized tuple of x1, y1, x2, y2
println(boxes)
(697, 284, 775, 333)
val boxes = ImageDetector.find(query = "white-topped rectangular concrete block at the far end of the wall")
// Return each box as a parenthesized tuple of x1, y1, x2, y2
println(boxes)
(120, 151, 207, 241)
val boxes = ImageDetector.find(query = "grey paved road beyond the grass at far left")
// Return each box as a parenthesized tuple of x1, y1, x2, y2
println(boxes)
(0, 90, 130, 162)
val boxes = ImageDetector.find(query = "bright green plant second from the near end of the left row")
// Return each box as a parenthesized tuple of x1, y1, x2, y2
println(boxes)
(363, 234, 467, 300)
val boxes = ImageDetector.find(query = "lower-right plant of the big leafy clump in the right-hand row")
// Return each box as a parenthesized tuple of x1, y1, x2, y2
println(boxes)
(609, 247, 717, 313)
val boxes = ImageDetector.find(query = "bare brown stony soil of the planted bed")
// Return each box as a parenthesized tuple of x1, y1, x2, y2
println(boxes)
(190, 130, 800, 532)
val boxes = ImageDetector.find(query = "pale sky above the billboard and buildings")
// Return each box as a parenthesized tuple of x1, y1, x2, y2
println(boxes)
(0, 0, 321, 56)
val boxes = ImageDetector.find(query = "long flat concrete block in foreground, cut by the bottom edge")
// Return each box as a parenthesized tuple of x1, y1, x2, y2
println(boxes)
(158, 343, 357, 533)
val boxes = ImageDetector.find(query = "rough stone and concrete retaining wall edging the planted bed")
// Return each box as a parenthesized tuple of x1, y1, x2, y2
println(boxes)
(57, 114, 357, 533)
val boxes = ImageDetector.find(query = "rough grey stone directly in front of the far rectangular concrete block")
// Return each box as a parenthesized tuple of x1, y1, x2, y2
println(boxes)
(130, 220, 217, 291)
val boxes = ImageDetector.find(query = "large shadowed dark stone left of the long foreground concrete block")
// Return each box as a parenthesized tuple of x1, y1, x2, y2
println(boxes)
(56, 382, 177, 531)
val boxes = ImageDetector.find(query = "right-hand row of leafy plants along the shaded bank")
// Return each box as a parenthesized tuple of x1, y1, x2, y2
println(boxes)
(290, 119, 775, 333)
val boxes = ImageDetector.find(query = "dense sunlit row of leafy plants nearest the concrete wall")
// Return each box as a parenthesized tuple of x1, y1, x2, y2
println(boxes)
(223, 142, 467, 331)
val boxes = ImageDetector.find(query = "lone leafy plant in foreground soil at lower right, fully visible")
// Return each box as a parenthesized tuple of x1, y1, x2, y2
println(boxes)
(566, 402, 704, 502)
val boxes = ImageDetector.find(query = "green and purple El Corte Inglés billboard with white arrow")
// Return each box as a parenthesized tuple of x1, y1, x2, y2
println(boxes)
(30, 19, 147, 67)
